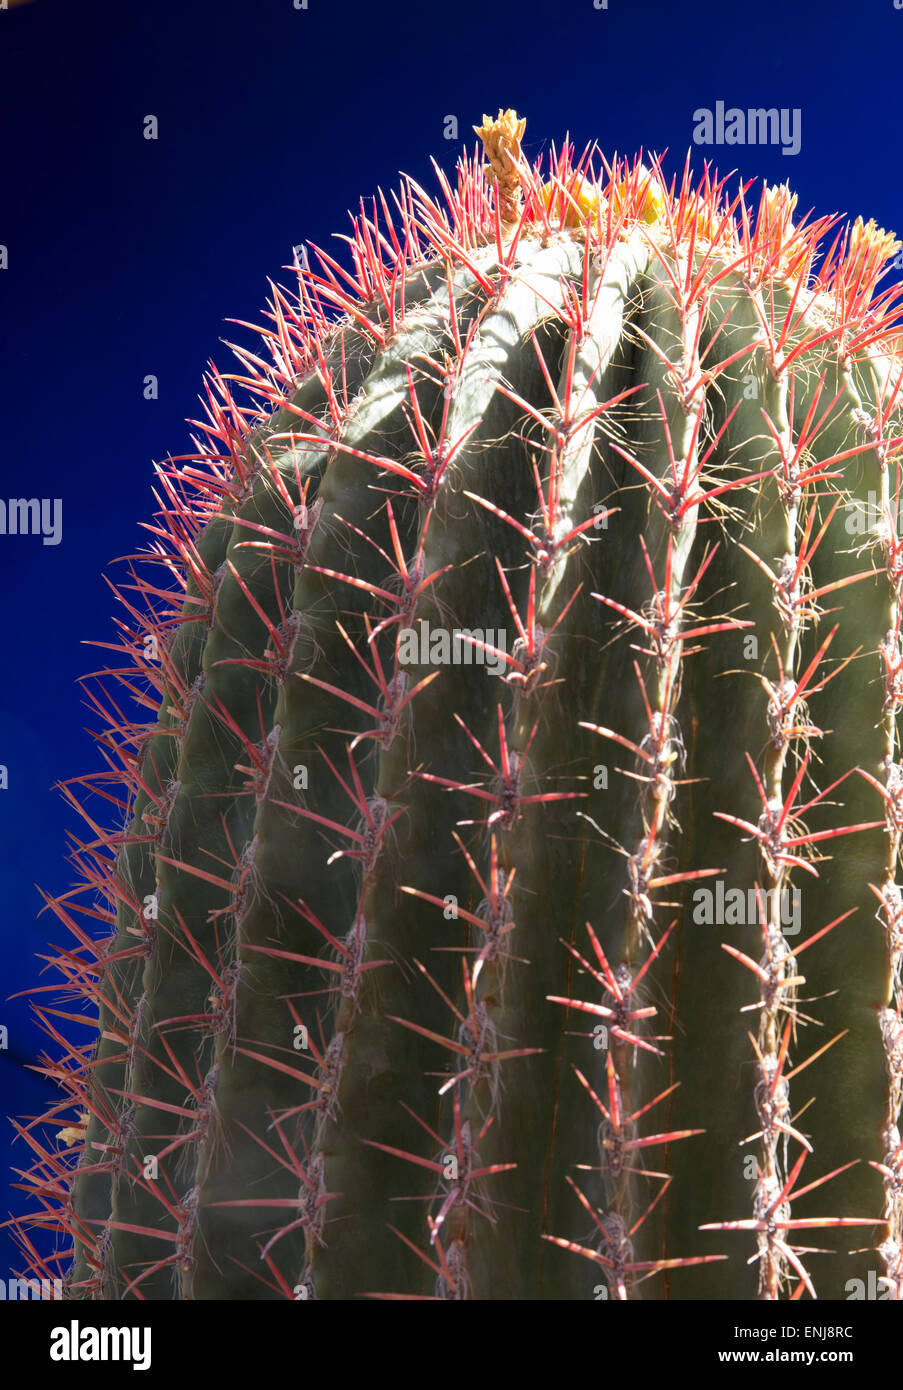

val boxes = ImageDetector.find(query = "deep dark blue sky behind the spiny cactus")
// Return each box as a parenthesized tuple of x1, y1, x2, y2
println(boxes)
(0, 0, 903, 1276)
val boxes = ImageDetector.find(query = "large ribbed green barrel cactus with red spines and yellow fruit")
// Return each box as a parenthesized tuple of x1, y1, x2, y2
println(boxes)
(11, 111, 903, 1300)
